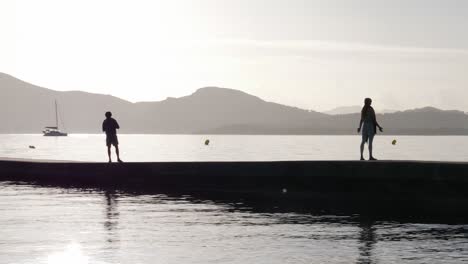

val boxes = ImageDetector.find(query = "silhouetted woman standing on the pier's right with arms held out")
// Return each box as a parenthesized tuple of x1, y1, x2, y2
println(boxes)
(358, 98, 383, 160)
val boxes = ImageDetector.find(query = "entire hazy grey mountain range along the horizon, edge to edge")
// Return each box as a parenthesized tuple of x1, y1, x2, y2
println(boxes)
(0, 73, 468, 135)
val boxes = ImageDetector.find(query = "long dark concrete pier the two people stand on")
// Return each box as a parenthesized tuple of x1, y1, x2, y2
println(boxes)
(0, 159, 468, 217)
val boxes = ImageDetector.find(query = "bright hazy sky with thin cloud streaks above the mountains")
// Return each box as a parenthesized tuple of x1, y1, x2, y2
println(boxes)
(0, 0, 468, 111)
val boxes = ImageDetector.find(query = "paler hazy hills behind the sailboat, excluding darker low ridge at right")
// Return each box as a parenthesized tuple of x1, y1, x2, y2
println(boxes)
(0, 74, 326, 133)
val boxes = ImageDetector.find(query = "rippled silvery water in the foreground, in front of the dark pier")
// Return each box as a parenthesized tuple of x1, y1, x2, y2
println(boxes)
(0, 182, 468, 264)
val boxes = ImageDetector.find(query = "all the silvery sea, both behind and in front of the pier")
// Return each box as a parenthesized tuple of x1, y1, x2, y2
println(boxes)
(0, 135, 468, 264)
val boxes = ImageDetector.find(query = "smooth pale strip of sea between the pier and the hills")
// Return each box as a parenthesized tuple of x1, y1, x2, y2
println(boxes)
(0, 134, 468, 162)
